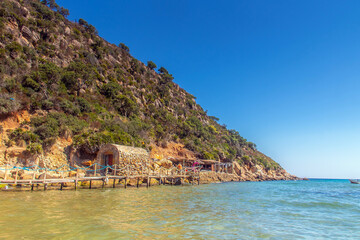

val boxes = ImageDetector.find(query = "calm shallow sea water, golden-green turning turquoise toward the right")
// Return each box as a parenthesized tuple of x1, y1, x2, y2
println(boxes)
(0, 180, 360, 239)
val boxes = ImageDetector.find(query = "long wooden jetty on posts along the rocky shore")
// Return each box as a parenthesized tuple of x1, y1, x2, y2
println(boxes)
(0, 164, 200, 191)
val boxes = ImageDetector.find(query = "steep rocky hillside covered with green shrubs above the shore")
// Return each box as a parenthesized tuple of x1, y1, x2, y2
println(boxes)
(0, 0, 296, 179)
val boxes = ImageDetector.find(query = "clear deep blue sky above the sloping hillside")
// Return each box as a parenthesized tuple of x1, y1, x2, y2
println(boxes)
(58, 0, 360, 178)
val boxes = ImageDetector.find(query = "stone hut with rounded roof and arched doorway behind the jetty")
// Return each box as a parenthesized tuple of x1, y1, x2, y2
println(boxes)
(96, 144, 150, 172)
